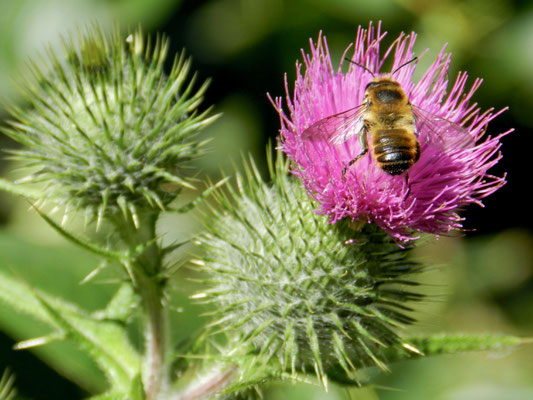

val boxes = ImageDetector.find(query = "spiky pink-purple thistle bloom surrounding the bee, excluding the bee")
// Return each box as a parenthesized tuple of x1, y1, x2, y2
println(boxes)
(272, 24, 511, 241)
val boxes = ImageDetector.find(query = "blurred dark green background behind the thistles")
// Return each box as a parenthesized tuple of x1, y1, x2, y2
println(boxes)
(0, 0, 533, 400)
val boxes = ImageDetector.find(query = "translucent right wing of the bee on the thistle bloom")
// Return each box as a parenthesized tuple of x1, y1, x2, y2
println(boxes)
(411, 105, 475, 151)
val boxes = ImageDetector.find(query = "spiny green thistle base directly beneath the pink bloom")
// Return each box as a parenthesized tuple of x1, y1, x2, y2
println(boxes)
(194, 152, 422, 384)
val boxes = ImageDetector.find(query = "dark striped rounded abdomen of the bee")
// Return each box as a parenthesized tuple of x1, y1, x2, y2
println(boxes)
(372, 129, 420, 175)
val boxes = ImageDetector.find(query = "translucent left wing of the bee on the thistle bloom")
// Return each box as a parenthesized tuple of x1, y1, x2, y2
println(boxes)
(302, 104, 367, 145)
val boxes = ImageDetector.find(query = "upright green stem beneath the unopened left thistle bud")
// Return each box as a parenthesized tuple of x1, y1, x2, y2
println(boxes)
(116, 213, 168, 400)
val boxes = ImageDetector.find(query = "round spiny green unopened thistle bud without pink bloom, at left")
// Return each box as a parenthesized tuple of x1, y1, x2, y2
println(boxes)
(5, 27, 216, 225)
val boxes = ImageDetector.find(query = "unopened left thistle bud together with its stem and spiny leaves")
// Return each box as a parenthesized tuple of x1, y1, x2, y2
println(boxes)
(0, 27, 218, 399)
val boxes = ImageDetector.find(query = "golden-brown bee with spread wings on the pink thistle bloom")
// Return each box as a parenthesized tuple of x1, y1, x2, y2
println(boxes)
(302, 58, 474, 176)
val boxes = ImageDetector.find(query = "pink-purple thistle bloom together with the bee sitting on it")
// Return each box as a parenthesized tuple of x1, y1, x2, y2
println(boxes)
(273, 24, 510, 241)
